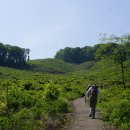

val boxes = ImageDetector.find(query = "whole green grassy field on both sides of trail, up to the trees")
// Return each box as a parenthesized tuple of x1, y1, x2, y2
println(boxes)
(0, 59, 130, 130)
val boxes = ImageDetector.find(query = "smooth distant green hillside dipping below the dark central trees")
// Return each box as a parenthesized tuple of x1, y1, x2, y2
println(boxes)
(29, 58, 95, 74)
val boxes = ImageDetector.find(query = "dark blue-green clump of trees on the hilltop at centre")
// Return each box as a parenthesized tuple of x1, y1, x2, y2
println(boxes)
(55, 46, 96, 64)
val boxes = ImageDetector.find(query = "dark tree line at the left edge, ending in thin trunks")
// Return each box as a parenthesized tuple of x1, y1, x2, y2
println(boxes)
(0, 43, 30, 67)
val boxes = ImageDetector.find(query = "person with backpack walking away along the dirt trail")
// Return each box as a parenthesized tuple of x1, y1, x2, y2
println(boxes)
(84, 84, 101, 118)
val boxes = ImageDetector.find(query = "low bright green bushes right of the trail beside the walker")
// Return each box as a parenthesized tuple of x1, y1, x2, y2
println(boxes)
(99, 87, 130, 130)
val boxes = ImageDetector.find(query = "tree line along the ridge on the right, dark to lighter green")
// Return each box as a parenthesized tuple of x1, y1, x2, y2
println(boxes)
(55, 35, 130, 64)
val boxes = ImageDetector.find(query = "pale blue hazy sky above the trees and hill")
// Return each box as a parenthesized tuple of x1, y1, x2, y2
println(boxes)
(0, 0, 130, 60)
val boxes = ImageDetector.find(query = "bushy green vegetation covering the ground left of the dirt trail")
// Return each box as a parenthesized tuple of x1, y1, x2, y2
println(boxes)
(0, 67, 85, 130)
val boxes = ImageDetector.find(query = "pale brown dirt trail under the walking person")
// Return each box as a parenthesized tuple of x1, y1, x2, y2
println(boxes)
(60, 98, 116, 130)
